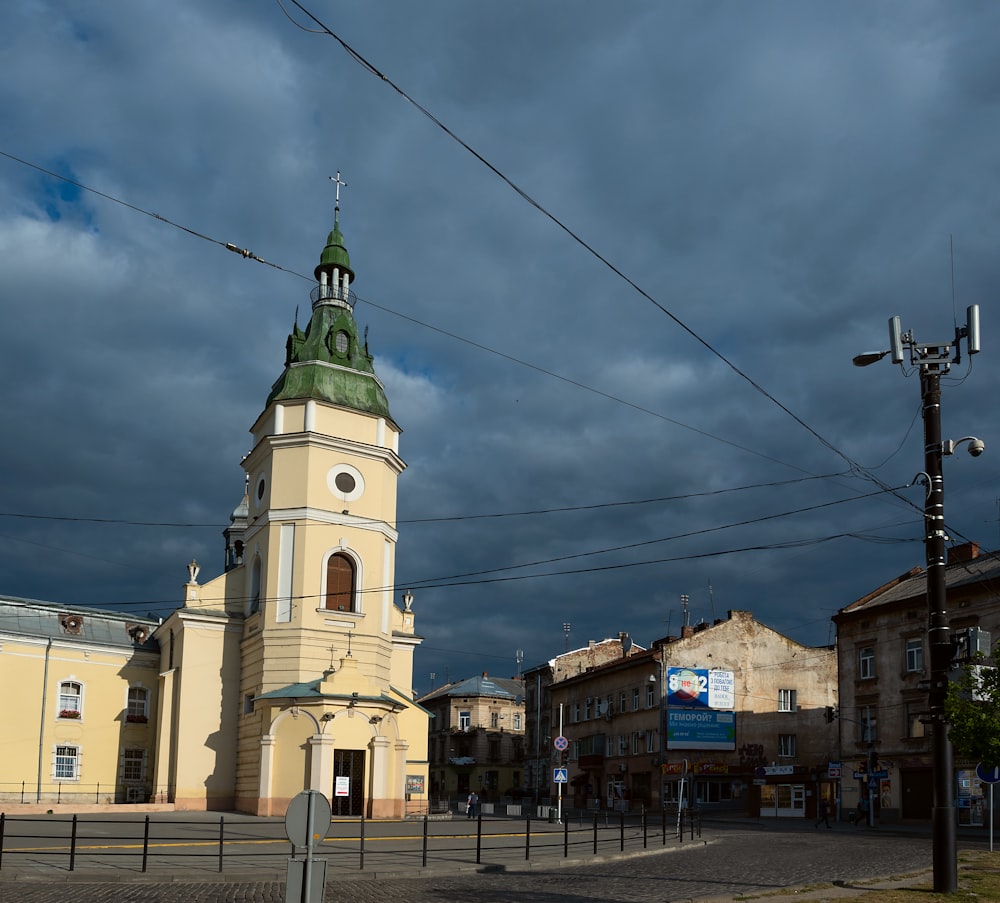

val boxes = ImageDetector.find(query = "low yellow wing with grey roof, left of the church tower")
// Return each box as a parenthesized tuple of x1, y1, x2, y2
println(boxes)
(0, 598, 160, 806)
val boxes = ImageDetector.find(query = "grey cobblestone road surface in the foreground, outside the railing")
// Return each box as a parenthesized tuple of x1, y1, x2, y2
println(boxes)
(0, 824, 982, 903)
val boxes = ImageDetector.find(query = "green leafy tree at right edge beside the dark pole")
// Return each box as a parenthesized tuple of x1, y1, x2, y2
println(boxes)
(945, 650, 1000, 767)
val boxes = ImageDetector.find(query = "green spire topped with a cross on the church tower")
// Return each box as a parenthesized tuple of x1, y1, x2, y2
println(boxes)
(268, 177, 390, 417)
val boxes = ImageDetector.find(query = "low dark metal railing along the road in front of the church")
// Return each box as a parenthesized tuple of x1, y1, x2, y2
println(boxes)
(0, 809, 701, 872)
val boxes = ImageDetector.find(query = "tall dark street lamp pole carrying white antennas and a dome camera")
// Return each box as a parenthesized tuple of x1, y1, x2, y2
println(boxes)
(854, 304, 986, 893)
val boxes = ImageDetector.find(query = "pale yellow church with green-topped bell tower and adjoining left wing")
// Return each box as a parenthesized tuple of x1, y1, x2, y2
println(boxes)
(0, 198, 429, 818)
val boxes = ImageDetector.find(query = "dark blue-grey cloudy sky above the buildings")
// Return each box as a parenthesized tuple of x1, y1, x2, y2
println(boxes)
(0, 0, 1000, 690)
